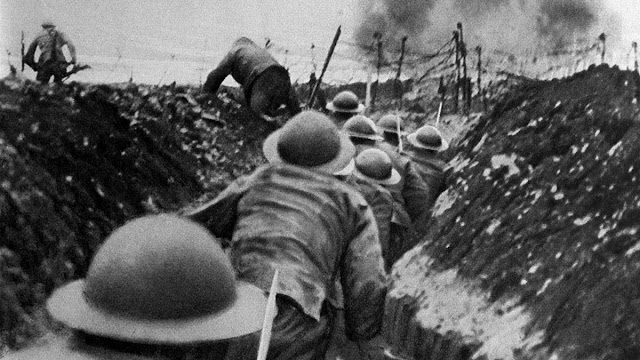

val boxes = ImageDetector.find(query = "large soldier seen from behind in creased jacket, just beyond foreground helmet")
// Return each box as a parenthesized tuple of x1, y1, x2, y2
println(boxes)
(187, 111, 386, 359)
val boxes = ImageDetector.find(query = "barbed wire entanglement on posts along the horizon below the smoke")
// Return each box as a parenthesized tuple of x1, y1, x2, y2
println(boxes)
(260, 23, 620, 113)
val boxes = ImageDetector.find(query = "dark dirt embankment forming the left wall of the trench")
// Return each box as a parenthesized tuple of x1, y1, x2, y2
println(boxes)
(0, 79, 272, 353)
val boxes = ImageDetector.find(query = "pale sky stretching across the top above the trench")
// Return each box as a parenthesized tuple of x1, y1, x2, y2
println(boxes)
(0, 0, 640, 80)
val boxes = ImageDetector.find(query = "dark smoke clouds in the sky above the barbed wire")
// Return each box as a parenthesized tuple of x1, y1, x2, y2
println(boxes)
(354, 0, 603, 53)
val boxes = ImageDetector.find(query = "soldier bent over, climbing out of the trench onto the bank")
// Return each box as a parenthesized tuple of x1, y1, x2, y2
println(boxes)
(202, 37, 300, 116)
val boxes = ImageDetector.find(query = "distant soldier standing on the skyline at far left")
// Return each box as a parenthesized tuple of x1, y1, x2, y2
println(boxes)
(23, 20, 76, 84)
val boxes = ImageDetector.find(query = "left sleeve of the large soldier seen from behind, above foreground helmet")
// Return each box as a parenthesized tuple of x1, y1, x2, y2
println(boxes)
(184, 178, 247, 239)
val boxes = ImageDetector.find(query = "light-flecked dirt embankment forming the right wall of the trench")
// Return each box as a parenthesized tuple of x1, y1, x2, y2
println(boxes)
(386, 66, 640, 359)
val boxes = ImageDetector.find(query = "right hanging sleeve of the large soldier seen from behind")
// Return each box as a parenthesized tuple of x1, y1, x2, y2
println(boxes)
(340, 203, 387, 341)
